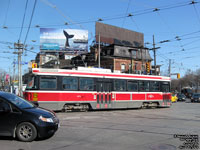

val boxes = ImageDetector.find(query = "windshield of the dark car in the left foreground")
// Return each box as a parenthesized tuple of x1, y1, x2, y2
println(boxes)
(1, 94, 35, 109)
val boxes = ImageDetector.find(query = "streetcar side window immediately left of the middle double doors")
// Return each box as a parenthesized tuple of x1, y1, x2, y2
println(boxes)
(79, 78, 94, 91)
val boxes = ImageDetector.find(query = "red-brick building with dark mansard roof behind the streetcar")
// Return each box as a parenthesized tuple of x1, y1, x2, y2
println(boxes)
(72, 45, 152, 74)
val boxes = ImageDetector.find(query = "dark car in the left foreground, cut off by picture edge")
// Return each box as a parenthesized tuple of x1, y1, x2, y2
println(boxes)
(0, 92, 59, 142)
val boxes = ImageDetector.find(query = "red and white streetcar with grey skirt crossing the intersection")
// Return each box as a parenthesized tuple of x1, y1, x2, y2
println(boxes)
(24, 67, 171, 111)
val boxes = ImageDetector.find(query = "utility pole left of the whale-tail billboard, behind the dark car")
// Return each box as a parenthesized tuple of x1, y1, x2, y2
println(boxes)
(14, 40, 24, 96)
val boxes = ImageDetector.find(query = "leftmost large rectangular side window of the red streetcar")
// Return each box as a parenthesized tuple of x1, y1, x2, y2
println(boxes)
(40, 77, 57, 89)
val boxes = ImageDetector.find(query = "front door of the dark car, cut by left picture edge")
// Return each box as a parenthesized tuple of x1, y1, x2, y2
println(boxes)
(0, 99, 21, 136)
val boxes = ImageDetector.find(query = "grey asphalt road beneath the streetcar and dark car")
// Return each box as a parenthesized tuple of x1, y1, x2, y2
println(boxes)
(0, 102, 200, 150)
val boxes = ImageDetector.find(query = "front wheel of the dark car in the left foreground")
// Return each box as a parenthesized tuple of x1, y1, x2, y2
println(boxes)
(16, 122, 37, 142)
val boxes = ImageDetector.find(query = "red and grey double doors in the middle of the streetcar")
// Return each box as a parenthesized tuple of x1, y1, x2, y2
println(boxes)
(96, 81, 112, 109)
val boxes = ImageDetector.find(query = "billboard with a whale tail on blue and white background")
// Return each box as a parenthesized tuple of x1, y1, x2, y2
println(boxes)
(40, 28, 88, 52)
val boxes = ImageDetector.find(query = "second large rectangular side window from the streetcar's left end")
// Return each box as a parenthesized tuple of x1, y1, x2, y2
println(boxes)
(62, 77, 78, 90)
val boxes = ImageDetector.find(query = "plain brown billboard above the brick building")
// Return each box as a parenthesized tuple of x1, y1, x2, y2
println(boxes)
(95, 22, 144, 47)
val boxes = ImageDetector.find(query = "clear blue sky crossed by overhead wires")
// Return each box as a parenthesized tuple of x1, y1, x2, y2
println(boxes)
(0, 0, 200, 77)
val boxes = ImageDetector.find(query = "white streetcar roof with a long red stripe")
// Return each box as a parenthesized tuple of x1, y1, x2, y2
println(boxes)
(32, 67, 171, 81)
